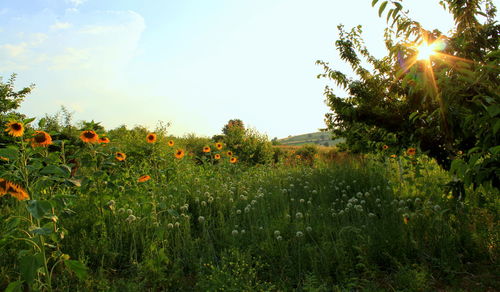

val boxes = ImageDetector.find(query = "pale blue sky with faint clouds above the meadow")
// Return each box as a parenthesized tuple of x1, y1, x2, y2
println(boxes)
(0, 0, 500, 139)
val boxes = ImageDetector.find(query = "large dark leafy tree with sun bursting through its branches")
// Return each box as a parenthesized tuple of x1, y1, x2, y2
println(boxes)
(317, 0, 500, 188)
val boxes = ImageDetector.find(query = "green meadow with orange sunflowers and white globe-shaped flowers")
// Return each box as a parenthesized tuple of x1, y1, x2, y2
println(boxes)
(0, 121, 499, 291)
